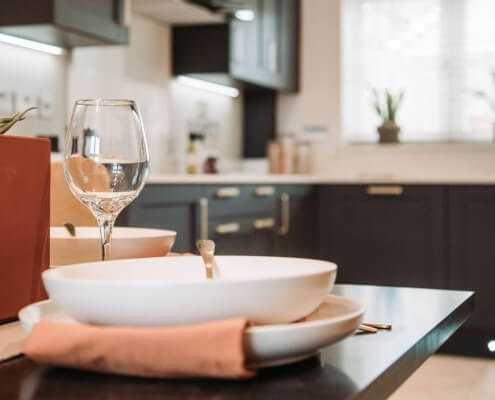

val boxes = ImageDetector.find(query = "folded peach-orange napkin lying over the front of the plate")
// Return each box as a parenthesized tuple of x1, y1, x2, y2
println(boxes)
(24, 318, 254, 379)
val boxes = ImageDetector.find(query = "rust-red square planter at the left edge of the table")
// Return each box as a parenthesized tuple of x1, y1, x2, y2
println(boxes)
(0, 135, 50, 321)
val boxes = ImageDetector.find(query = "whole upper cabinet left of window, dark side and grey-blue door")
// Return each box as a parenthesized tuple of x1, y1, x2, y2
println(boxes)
(176, 0, 299, 92)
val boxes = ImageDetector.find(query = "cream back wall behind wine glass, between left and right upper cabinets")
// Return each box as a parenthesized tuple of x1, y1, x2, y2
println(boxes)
(68, 15, 241, 172)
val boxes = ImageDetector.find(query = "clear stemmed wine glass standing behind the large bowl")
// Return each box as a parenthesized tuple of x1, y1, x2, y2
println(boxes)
(63, 99, 149, 260)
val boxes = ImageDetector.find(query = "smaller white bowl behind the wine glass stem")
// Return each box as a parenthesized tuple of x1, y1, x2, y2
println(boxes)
(50, 226, 176, 266)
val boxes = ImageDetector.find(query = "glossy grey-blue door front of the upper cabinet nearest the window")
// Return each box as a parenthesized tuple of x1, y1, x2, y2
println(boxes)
(230, 0, 300, 92)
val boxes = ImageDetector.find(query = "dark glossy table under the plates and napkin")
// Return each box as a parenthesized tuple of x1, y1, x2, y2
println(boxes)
(0, 285, 474, 400)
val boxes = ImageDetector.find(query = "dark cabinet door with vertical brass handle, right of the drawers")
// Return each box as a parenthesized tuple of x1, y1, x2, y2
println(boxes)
(275, 185, 317, 258)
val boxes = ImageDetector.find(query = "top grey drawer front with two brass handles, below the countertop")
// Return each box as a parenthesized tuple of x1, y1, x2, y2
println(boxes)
(204, 185, 277, 217)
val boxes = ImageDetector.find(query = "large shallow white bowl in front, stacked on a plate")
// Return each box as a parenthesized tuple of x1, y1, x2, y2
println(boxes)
(43, 256, 337, 326)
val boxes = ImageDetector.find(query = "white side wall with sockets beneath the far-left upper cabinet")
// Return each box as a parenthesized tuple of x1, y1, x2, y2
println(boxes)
(0, 43, 67, 141)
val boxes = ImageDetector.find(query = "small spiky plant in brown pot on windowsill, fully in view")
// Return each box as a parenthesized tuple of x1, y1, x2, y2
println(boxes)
(373, 89, 404, 143)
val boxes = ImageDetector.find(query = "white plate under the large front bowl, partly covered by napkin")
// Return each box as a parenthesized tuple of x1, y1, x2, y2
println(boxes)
(19, 295, 364, 367)
